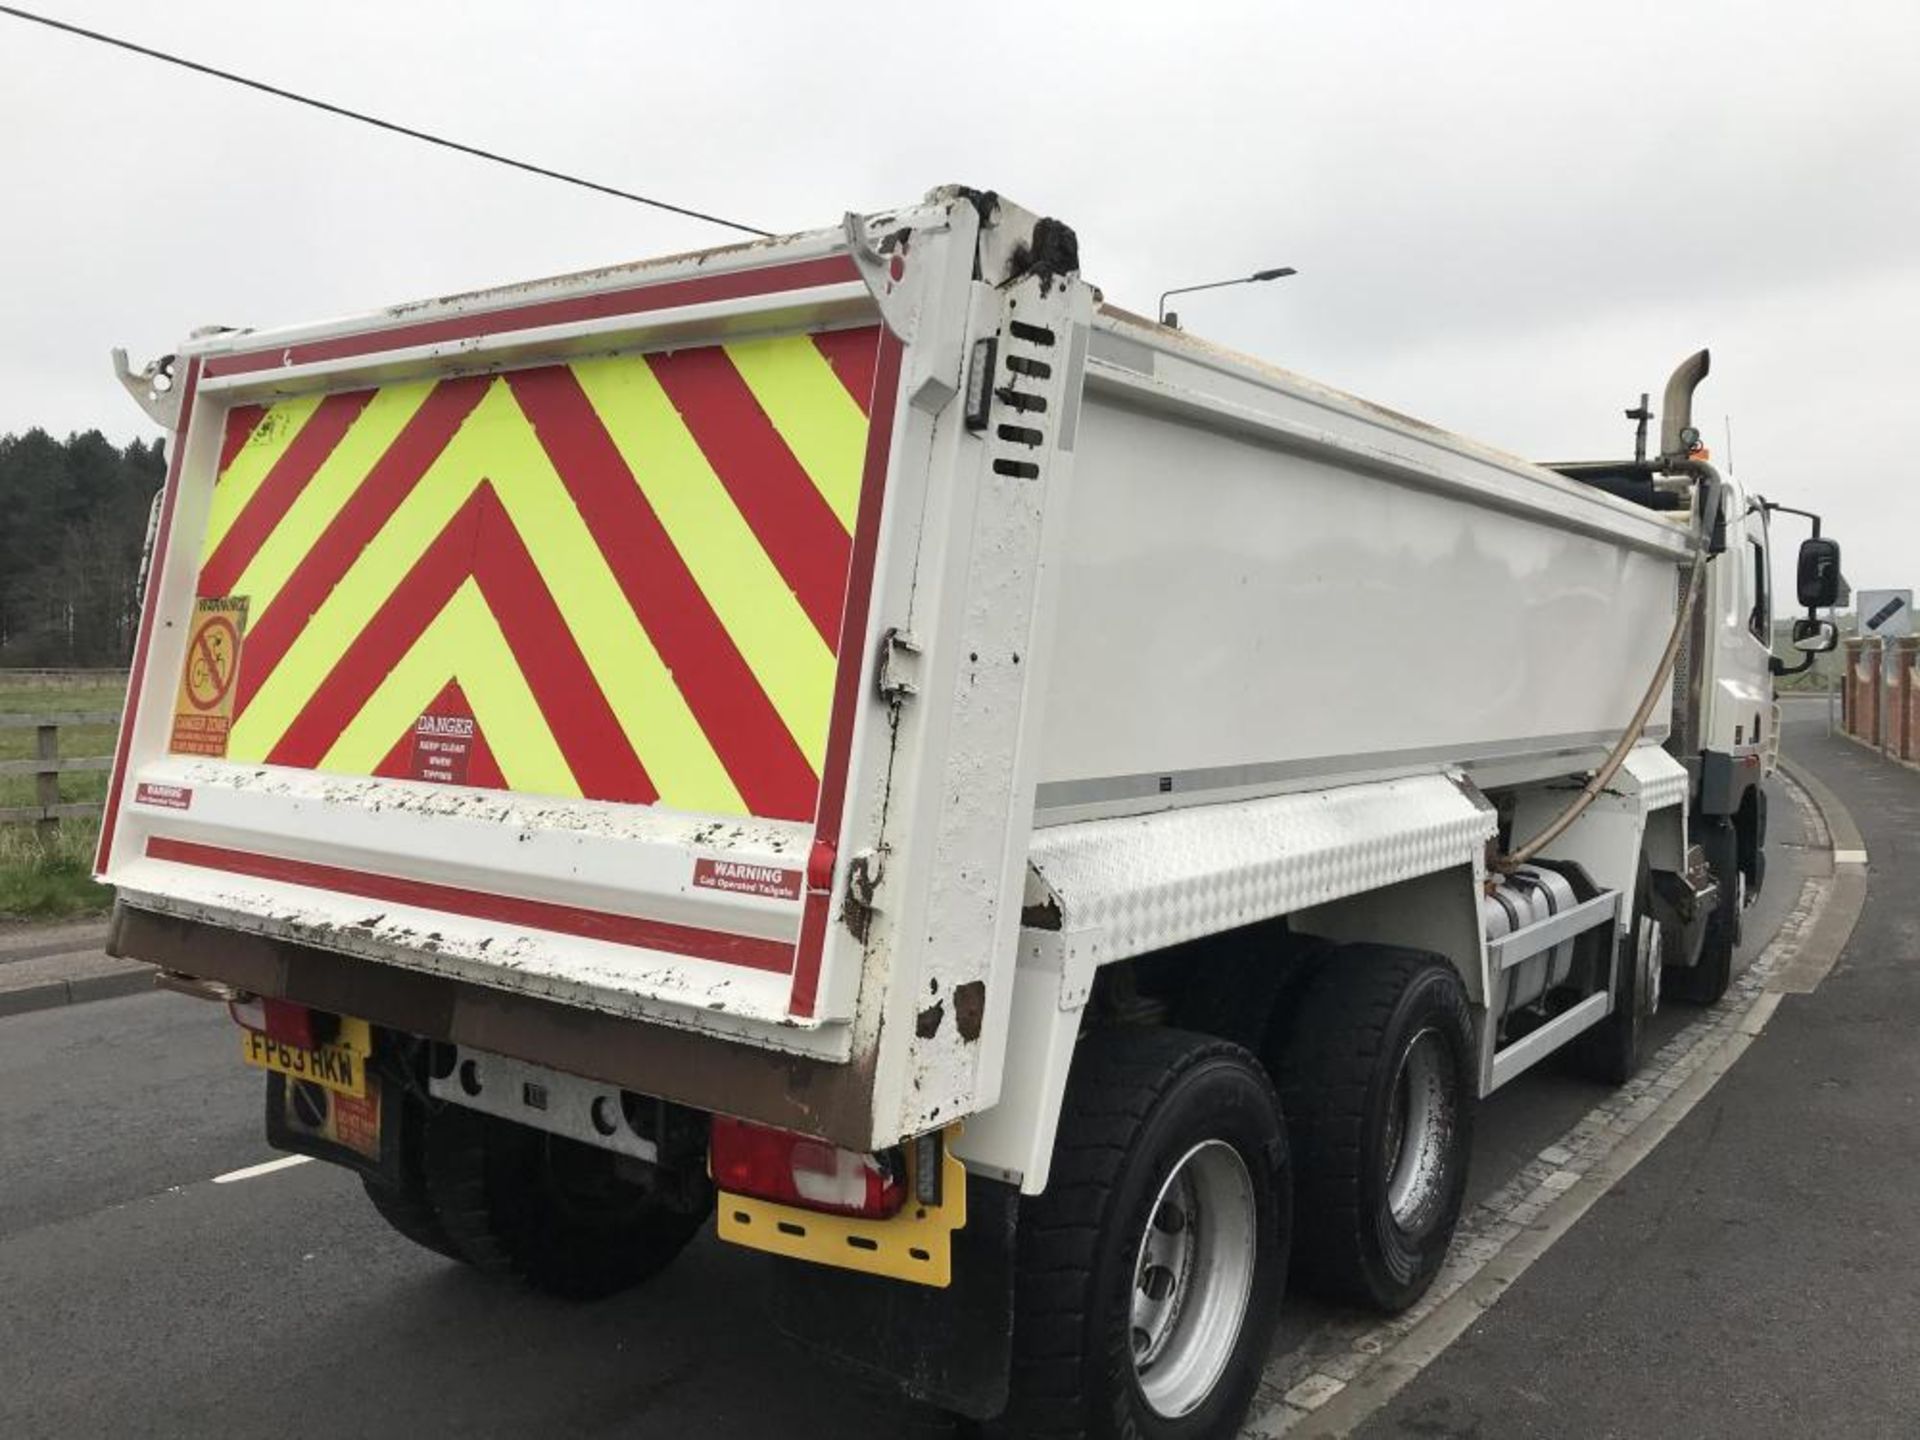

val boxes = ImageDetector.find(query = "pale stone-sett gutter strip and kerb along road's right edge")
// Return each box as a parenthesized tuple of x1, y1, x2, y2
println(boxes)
(1240, 783, 1845, 1440)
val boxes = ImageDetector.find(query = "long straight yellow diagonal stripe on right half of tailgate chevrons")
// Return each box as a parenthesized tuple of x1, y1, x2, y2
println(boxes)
(572, 359, 845, 774)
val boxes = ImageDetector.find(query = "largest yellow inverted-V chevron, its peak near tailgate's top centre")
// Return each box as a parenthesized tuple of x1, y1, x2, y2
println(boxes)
(228, 380, 747, 814)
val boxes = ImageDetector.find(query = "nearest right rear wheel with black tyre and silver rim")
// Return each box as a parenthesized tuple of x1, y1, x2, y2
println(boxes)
(1006, 1027, 1290, 1440)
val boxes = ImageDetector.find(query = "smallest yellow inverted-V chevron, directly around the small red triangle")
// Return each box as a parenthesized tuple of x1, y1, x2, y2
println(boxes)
(317, 580, 580, 797)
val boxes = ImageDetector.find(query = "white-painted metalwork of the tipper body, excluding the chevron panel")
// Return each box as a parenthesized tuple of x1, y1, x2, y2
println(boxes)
(102, 192, 1718, 1190)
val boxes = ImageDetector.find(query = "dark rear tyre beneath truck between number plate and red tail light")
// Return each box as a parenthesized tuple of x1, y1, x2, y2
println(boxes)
(426, 1106, 714, 1300)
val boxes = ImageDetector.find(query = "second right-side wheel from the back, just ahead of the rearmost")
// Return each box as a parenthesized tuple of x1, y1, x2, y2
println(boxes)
(1271, 945, 1478, 1313)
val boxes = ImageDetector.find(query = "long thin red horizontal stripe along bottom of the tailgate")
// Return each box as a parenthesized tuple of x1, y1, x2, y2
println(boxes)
(146, 835, 793, 975)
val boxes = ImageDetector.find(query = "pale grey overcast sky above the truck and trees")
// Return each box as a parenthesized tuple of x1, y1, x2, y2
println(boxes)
(0, 0, 1920, 599)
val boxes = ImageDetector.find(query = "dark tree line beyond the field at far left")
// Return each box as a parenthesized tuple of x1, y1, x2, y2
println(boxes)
(0, 430, 167, 668)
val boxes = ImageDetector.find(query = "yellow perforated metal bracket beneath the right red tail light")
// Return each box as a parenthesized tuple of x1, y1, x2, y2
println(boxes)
(718, 1125, 966, 1290)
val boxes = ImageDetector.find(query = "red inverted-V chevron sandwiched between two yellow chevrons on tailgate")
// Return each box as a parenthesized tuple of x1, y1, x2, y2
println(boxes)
(267, 482, 660, 804)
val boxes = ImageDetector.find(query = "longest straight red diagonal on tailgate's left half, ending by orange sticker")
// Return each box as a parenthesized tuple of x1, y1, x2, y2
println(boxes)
(233, 374, 493, 714)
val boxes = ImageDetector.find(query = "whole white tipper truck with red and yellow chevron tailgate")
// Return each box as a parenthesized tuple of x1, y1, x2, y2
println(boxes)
(96, 186, 1839, 1436)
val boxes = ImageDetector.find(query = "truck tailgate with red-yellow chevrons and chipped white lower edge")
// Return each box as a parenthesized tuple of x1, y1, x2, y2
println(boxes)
(98, 242, 900, 1048)
